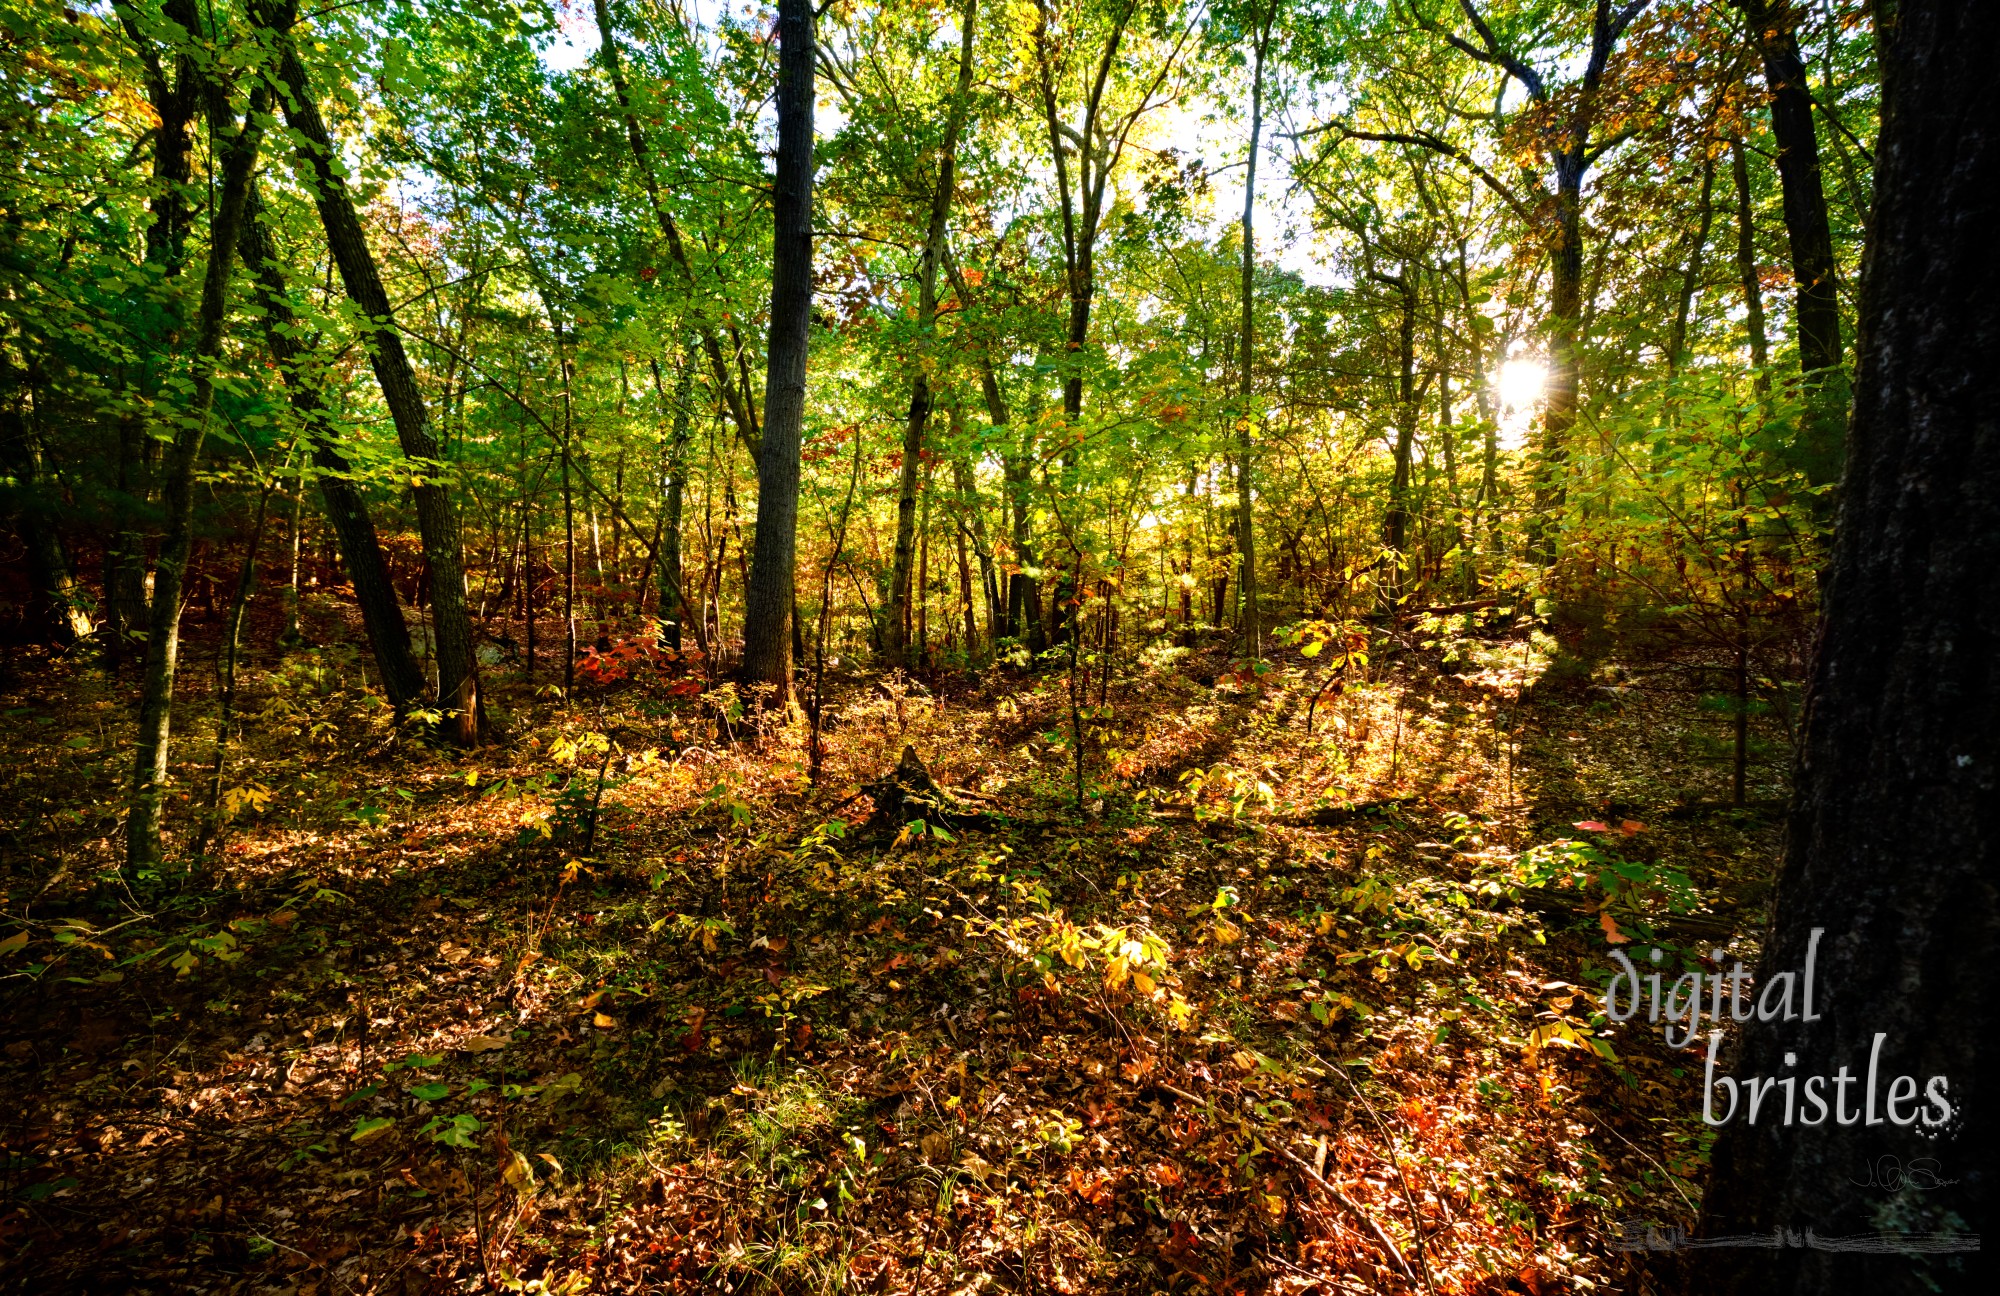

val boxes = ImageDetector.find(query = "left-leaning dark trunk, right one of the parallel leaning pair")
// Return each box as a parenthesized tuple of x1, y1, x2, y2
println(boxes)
(250, 0, 482, 746)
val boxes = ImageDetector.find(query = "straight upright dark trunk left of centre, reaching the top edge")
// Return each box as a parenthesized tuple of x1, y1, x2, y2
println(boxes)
(744, 0, 812, 692)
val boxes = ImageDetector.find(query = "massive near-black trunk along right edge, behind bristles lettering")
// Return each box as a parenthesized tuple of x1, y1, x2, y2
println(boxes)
(1692, 0, 2000, 1294)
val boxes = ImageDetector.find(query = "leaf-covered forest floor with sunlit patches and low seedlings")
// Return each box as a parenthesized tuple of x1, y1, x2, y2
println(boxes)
(0, 602, 1782, 1296)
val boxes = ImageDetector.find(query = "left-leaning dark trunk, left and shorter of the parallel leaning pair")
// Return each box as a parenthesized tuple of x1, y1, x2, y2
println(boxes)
(240, 192, 430, 716)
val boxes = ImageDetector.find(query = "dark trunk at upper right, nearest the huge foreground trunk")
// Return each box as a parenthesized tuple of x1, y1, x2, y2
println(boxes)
(1742, 0, 1846, 484)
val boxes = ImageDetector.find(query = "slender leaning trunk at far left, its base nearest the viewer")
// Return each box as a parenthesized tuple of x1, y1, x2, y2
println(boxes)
(126, 84, 270, 870)
